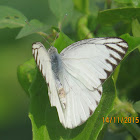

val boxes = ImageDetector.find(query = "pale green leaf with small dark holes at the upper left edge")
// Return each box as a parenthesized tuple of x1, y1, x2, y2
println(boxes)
(0, 6, 27, 28)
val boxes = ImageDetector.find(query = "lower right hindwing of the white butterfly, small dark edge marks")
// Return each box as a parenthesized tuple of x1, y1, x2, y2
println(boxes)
(60, 67, 102, 129)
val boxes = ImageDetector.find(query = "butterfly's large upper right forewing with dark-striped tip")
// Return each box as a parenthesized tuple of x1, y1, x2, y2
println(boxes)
(60, 38, 128, 90)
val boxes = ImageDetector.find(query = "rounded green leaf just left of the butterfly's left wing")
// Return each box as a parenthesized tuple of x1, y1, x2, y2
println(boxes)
(17, 59, 36, 95)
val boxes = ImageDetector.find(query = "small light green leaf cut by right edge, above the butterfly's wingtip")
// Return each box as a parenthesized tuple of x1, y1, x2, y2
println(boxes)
(132, 19, 140, 37)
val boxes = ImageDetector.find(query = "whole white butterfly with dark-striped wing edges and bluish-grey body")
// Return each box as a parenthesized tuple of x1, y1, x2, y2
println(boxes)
(32, 38, 128, 129)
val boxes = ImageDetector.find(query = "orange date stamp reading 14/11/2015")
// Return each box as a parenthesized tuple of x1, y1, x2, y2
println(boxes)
(103, 117, 139, 123)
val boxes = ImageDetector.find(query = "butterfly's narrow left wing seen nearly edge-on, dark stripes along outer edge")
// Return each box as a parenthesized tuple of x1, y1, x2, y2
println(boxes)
(32, 42, 65, 125)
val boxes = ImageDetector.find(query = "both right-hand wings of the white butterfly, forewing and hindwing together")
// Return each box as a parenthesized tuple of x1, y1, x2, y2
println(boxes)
(59, 38, 128, 128)
